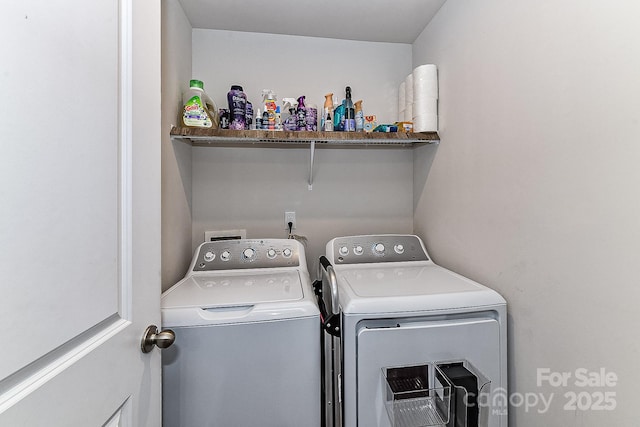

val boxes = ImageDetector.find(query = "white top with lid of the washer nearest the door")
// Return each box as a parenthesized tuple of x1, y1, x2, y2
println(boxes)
(162, 270, 303, 309)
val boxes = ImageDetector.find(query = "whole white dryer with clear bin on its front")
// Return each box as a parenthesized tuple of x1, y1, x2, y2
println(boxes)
(320, 235, 507, 427)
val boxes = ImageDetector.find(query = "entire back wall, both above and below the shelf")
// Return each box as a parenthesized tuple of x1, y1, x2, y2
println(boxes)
(192, 29, 413, 270)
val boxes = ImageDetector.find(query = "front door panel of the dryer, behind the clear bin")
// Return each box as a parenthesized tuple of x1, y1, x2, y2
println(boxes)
(356, 313, 504, 427)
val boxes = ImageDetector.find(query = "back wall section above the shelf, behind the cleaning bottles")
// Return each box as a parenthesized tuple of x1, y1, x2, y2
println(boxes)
(193, 29, 411, 123)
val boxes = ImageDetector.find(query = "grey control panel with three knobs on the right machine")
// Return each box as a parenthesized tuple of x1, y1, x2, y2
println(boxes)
(331, 234, 429, 264)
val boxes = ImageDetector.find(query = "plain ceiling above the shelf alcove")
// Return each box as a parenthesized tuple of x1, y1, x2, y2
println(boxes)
(180, 0, 445, 44)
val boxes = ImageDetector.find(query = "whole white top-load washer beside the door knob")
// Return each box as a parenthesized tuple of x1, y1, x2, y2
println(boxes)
(162, 239, 321, 427)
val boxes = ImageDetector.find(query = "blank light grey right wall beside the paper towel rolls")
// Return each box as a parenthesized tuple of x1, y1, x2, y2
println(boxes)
(413, 0, 640, 427)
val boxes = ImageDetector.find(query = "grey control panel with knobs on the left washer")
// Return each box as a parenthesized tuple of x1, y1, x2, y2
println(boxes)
(192, 239, 300, 271)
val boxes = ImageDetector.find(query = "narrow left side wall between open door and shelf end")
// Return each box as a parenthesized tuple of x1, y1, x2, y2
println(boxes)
(162, 0, 192, 290)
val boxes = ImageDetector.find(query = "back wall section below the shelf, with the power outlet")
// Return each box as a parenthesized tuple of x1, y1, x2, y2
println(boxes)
(193, 147, 413, 277)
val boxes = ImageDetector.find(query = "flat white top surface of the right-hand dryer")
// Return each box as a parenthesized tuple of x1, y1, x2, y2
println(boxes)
(336, 262, 505, 313)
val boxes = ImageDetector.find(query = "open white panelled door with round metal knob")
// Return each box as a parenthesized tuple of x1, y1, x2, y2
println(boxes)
(0, 0, 160, 427)
